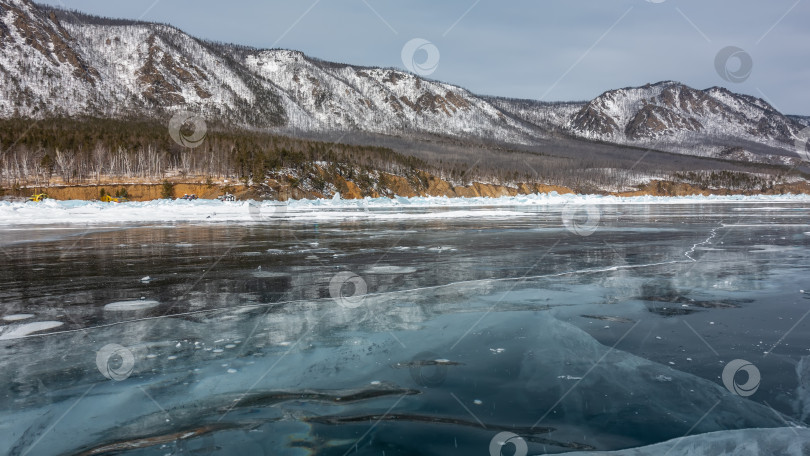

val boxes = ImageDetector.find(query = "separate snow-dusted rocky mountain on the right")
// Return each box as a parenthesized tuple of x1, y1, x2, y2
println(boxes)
(498, 81, 806, 162)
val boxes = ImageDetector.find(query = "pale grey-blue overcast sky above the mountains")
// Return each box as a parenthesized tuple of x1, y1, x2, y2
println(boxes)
(34, 0, 810, 115)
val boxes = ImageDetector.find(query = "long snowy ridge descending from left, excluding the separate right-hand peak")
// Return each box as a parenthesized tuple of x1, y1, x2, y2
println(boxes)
(0, 0, 537, 142)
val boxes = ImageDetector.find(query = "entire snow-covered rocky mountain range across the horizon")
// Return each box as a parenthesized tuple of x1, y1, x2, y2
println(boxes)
(0, 0, 806, 161)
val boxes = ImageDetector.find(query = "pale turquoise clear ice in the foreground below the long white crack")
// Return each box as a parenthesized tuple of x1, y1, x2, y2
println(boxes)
(0, 282, 800, 454)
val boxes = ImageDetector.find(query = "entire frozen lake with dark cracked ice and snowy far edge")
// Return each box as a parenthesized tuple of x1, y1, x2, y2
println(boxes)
(0, 198, 810, 456)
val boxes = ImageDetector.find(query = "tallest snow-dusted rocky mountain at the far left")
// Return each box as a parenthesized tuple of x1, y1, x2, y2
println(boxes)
(0, 0, 287, 126)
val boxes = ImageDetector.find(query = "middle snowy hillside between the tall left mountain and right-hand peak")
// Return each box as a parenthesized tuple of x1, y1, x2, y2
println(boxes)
(245, 50, 528, 142)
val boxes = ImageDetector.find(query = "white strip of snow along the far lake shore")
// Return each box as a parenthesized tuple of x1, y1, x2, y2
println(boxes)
(0, 192, 810, 226)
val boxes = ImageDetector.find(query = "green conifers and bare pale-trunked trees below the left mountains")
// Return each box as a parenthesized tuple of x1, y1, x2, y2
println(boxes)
(0, 119, 430, 187)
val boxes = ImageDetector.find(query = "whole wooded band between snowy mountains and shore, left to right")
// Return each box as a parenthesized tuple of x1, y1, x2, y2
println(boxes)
(0, 118, 807, 198)
